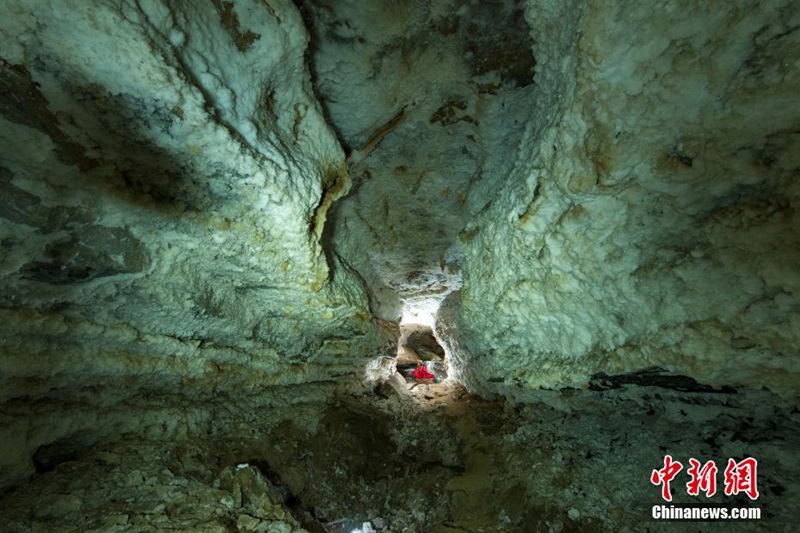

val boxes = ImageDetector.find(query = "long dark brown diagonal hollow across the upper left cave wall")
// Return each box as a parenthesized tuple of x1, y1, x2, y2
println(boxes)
(0, 59, 231, 216)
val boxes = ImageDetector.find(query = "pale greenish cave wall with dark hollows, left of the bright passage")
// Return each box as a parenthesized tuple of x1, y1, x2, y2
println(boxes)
(0, 0, 383, 488)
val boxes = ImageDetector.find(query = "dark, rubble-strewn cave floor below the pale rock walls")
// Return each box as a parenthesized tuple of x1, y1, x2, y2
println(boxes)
(0, 383, 800, 533)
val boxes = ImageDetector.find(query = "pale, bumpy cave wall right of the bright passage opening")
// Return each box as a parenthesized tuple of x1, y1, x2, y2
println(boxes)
(450, 1, 800, 395)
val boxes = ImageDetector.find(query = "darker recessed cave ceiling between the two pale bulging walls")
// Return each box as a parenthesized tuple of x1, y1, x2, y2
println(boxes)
(298, 0, 536, 321)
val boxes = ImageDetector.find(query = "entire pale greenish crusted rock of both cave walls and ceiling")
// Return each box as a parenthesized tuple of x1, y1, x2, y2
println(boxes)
(0, 0, 800, 500)
